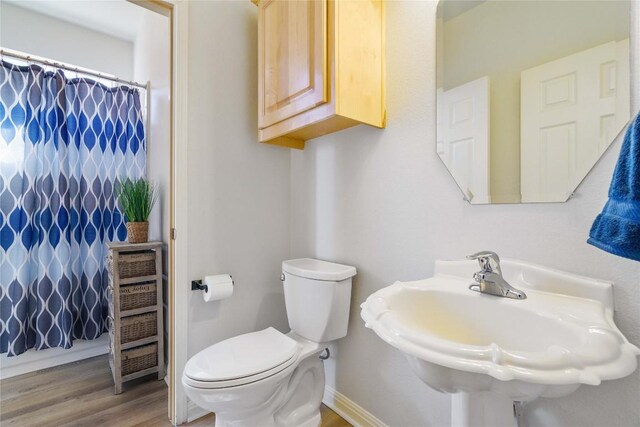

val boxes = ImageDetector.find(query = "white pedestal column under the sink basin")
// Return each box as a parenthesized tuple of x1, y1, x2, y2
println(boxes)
(451, 391, 517, 427)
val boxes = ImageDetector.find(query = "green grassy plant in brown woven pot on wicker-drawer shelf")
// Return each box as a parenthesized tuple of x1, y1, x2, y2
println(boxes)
(116, 178, 158, 243)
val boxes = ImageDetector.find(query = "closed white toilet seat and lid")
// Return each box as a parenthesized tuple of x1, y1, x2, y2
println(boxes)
(183, 327, 301, 389)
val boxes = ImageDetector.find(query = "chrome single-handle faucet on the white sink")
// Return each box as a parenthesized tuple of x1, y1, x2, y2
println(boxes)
(467, 251, 527, 299)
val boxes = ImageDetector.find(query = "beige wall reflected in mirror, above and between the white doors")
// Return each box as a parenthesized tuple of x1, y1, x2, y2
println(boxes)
(438, 1, 629, 203)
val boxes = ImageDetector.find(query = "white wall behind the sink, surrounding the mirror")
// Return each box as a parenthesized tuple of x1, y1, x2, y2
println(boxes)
(291, 1, 640, 427)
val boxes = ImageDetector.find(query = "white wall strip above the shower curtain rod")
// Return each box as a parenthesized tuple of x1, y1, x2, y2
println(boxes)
(0, 1, 133, 80)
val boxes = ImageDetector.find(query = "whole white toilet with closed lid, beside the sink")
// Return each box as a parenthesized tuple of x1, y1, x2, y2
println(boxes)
(182, 258, 356, 427)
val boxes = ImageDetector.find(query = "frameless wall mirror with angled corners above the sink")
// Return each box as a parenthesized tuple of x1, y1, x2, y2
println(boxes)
(436, 0, 631, 204)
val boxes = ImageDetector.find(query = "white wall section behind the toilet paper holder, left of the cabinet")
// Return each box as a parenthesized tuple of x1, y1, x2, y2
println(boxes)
(185, 0, 290, 356)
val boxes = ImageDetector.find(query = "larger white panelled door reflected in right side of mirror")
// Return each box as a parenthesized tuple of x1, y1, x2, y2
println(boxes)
(520, 40, 630, 202)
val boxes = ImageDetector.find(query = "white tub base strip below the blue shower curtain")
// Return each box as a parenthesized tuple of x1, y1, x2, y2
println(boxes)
(0, 334, 109, 380)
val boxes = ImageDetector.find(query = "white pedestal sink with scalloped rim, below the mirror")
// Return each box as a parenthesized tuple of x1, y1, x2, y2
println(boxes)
(361, 260, 640, 427)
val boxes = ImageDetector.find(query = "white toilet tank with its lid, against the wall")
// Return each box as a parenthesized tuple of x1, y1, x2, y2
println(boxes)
(282, 258, 356, 343)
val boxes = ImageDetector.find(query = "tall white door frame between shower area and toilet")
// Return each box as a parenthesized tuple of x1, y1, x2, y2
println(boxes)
(127, 0, 189, 425)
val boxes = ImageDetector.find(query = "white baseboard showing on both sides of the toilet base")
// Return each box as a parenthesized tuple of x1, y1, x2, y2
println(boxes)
(182, 386, 387, 427)
